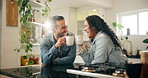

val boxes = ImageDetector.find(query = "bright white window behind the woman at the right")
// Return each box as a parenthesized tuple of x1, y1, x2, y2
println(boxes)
(119, 10, 148, 35)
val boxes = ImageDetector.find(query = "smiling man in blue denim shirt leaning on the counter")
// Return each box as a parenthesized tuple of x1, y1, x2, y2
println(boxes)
(40, 16, 76, 66)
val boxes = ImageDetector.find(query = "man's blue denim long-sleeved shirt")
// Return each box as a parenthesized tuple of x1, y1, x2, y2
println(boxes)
(40, 33, 76, 65)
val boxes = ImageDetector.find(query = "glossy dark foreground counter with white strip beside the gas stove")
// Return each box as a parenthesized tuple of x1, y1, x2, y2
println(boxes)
(0, 64, 122, 78)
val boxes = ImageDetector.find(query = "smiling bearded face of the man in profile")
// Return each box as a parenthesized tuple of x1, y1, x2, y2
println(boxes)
(55, 20, 68, 37)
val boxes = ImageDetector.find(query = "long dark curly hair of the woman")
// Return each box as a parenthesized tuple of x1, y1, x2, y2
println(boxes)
(86, 15, 121, 48)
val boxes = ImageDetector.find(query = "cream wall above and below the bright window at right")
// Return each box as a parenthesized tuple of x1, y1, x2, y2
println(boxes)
(106, 0, 148, 54)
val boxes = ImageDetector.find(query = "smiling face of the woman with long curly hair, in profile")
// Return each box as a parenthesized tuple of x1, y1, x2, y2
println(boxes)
(84, 21, 97, 38)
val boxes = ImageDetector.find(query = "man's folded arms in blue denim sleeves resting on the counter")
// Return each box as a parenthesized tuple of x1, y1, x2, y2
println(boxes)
(40, 40, 76, 65)
